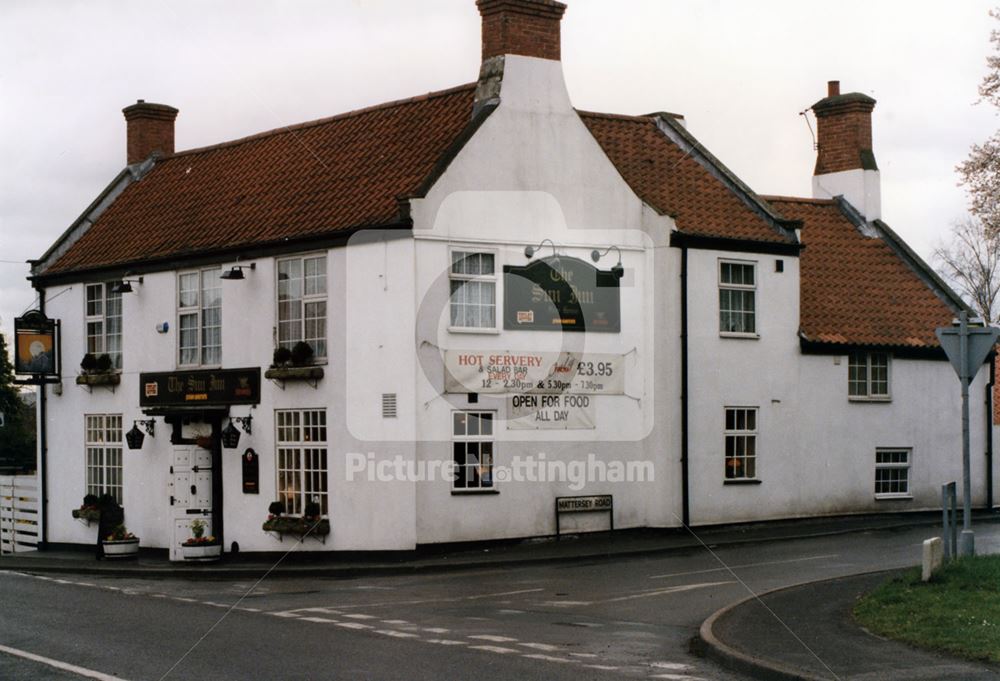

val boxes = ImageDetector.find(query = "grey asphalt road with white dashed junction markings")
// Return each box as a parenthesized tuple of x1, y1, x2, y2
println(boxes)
(0, 524, 1000, 681)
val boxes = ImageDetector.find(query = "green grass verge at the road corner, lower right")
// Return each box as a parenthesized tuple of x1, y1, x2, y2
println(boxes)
(854, 555, 1000, 662)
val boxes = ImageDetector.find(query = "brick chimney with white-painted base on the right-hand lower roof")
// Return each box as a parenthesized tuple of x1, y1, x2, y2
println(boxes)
(812, 80, 881, 221)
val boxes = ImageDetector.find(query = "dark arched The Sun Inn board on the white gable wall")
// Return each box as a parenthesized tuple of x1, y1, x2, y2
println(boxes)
(503, 256, 621, 333)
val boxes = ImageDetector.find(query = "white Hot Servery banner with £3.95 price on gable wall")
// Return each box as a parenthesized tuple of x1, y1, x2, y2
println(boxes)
(444, 350, 625, 395)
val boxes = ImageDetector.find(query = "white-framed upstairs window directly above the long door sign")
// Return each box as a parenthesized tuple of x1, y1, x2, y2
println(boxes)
(177, 268, 222, 366)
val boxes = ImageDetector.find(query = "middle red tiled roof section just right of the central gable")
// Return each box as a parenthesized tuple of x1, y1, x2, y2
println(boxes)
(580, 111, 790, 243)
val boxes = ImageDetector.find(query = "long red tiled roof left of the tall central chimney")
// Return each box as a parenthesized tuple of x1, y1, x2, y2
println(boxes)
(46, 85, 475, 274)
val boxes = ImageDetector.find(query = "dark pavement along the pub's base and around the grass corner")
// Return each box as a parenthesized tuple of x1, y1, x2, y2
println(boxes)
(0, 513, 1000, 681)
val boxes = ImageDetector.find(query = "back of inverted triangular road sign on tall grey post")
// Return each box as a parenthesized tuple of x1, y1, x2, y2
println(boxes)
(935, 310, 1000, 556)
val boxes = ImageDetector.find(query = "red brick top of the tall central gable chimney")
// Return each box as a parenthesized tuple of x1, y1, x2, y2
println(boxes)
(476, 0, 566, 62)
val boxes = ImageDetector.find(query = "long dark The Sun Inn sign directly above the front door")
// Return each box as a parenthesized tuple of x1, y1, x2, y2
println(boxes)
(139, 367, 260, 408)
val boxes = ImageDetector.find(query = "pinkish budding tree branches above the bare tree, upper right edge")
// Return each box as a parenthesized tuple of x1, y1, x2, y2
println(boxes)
(956, 8, 1000, 232)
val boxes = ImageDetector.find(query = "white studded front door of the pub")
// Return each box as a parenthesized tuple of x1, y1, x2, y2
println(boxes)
(169, 445, 213, 560)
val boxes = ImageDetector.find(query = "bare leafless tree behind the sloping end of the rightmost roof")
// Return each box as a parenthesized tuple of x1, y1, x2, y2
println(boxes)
(934, 217, 1000, 324)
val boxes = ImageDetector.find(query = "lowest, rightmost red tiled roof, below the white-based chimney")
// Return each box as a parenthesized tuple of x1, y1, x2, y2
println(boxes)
(765, 197, 955, 348)
